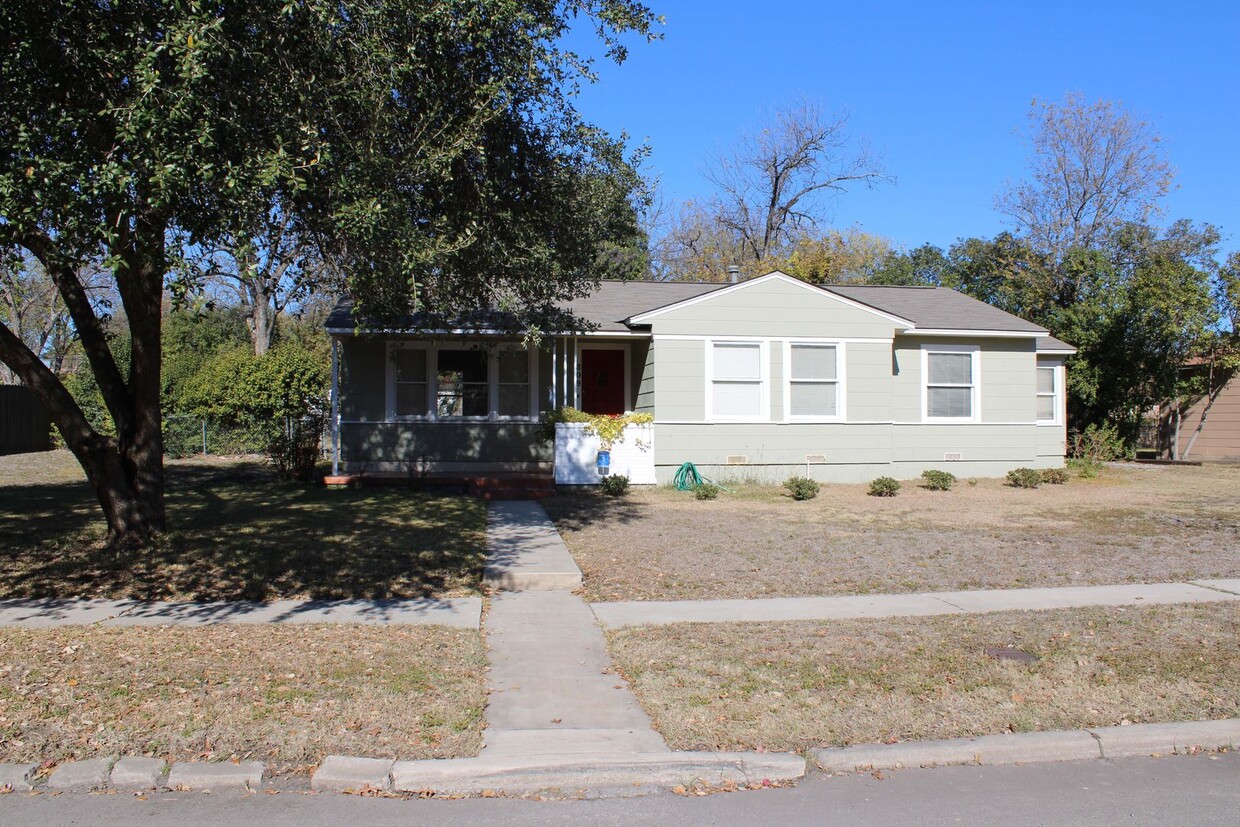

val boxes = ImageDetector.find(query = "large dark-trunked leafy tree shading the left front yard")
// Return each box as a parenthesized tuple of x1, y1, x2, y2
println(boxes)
(0, 0, 656, 539)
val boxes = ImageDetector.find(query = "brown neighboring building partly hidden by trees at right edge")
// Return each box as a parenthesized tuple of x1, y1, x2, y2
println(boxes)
(1158, 365, 1240, 461)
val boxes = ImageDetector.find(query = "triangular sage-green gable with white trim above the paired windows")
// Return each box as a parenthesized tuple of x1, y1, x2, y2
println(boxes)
(651, 279, 903, 338)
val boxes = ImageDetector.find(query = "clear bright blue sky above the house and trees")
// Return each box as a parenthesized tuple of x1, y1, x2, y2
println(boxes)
(567, 0, 1240, 259)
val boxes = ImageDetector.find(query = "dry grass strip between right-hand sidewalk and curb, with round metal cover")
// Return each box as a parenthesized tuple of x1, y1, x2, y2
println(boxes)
(610, 604, 1240, 751)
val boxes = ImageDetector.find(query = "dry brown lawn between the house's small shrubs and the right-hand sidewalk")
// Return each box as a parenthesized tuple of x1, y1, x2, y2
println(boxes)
(546, 465, 1240, 600)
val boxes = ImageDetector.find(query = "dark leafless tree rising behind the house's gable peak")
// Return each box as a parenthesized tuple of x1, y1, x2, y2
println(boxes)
(706, 103, 892, 264)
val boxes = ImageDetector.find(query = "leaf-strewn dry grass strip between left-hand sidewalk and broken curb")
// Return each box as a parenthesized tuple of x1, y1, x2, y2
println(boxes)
(0, 626, 486, 769)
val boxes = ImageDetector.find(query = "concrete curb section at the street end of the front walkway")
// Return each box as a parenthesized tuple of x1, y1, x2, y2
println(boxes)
(392, 753, 806, 795)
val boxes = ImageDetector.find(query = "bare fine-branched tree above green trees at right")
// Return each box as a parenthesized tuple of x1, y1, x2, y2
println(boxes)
(996, 92, 1174, 262)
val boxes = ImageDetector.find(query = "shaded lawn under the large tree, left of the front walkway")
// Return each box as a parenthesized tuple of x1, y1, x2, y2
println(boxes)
(0, 462, 486, 600)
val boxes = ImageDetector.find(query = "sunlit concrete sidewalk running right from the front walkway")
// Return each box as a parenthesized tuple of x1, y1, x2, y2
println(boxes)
(590, 579, 1240, 627)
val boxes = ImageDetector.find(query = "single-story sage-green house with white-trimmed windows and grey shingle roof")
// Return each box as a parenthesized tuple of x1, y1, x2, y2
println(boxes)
(327, 273, 1075, 482)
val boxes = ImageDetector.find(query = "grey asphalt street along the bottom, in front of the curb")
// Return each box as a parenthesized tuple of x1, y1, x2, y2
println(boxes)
(0, 753, 1240, 827)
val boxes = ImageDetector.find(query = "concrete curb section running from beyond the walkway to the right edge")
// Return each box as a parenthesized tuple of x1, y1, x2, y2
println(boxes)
(813, 718, 1240, 772)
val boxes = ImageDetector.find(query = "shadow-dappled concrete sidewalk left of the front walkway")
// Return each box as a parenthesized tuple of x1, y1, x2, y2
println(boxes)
(0, 598, 482, 629)
